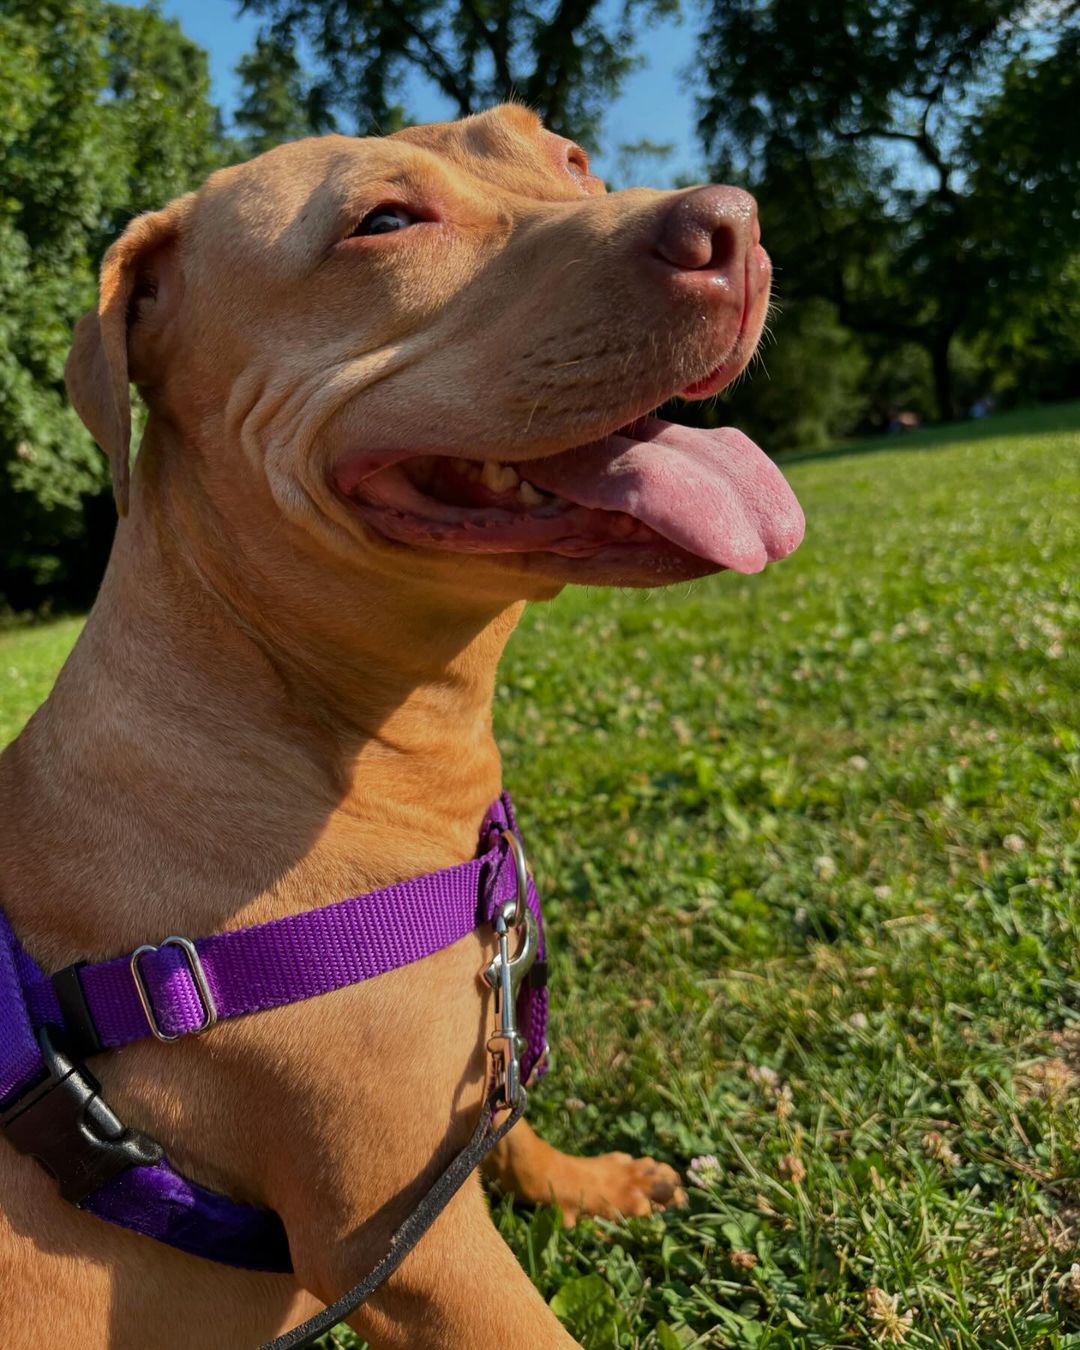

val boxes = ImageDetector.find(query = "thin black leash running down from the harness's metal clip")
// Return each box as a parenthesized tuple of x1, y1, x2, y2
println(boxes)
(259, 1088, 525, 1350)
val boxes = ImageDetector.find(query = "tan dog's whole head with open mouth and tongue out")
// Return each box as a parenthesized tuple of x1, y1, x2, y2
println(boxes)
(68, 105, 803, 595)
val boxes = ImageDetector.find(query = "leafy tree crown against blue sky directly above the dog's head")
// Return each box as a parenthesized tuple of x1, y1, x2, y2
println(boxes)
(242, 0, 678, 140)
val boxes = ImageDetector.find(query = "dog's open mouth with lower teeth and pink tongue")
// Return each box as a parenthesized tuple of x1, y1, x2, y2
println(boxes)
(333, 417, 803, 579)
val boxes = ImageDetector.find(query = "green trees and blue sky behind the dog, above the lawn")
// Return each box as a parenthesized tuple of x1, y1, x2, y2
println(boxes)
(0, 0, 1080, 613)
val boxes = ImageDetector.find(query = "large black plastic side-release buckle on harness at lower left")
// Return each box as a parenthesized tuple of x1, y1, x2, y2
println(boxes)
(0, 1026, 163, 1206)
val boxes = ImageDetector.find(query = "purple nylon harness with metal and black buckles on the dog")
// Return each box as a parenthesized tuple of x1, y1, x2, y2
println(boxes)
(0, 794, 548, 1272)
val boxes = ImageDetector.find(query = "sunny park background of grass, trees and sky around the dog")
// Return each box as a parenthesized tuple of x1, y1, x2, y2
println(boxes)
(0, 0, 1080, 1350)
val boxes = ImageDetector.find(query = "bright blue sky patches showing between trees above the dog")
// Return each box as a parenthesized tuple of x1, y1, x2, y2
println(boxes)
(151, 0, 705, 186)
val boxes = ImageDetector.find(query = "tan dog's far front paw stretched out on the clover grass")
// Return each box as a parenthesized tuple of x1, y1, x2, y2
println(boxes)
(485, 1121, 686, 1224)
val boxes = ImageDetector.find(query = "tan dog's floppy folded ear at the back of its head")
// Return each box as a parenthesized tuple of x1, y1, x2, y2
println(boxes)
(63, 196, 192, 516)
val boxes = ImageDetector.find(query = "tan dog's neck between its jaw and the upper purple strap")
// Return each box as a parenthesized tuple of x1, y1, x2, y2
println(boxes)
(0, 437, 521, 960)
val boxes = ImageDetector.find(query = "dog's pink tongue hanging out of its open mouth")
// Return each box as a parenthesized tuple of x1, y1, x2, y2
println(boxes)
(514, 417, 805, 572)
